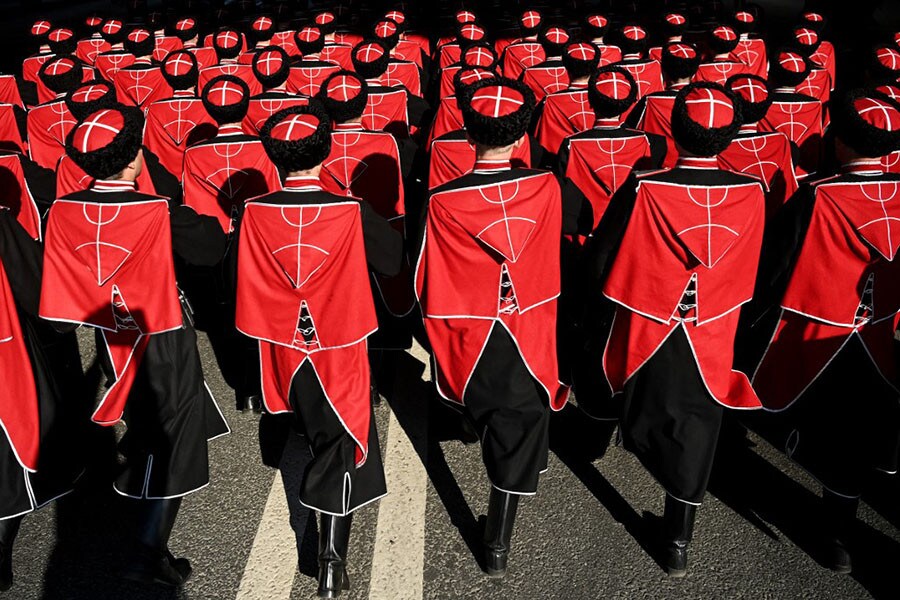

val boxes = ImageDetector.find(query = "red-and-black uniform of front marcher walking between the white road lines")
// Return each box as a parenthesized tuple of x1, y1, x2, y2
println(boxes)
(236, 178, 402, 516)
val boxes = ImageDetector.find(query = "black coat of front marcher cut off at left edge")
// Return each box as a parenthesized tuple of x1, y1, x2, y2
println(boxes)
(0, 211, 90, 518)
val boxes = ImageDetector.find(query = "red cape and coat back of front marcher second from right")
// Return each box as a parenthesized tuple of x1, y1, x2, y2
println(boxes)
(603, 173, 765, 408)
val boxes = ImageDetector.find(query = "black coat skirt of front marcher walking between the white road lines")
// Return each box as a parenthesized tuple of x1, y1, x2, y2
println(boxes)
(290, 361, 387, 516)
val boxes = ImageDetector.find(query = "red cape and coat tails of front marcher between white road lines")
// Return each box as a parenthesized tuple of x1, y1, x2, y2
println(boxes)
(235, 198, 378, 464)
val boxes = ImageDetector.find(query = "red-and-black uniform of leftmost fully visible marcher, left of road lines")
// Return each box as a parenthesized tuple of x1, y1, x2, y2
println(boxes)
(40, 180, 228, 499)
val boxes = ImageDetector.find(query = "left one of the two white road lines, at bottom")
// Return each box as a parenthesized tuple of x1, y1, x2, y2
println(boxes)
(237, 473, 297, 600)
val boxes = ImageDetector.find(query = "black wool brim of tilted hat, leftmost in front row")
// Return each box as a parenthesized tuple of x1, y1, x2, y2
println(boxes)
(66, 105, 144, 179)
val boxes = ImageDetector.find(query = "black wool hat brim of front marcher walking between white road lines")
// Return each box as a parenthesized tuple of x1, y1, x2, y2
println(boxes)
(259, 101, 331, 173)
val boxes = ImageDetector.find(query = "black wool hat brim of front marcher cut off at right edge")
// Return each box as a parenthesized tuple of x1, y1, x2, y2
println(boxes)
(831, 89, 900, 158)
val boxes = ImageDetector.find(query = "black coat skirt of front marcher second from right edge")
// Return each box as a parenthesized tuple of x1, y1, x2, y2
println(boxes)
(620, 325, 724, 504)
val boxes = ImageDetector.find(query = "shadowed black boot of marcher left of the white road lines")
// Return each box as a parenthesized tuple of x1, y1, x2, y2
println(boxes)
(123, 498, 193, 587)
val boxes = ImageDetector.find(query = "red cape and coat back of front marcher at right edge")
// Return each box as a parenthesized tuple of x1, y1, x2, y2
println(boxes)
(754, 181, 900, 410)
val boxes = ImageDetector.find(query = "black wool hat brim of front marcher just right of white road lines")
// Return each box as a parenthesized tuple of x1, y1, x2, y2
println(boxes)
(458, 79, 535, 148)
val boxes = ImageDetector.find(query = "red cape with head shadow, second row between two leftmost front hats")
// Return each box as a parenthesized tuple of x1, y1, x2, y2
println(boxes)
(182, 137, 281, 233)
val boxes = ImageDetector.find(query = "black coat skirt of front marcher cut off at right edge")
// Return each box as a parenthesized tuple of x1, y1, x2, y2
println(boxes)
(779, 335, 900, 496)
